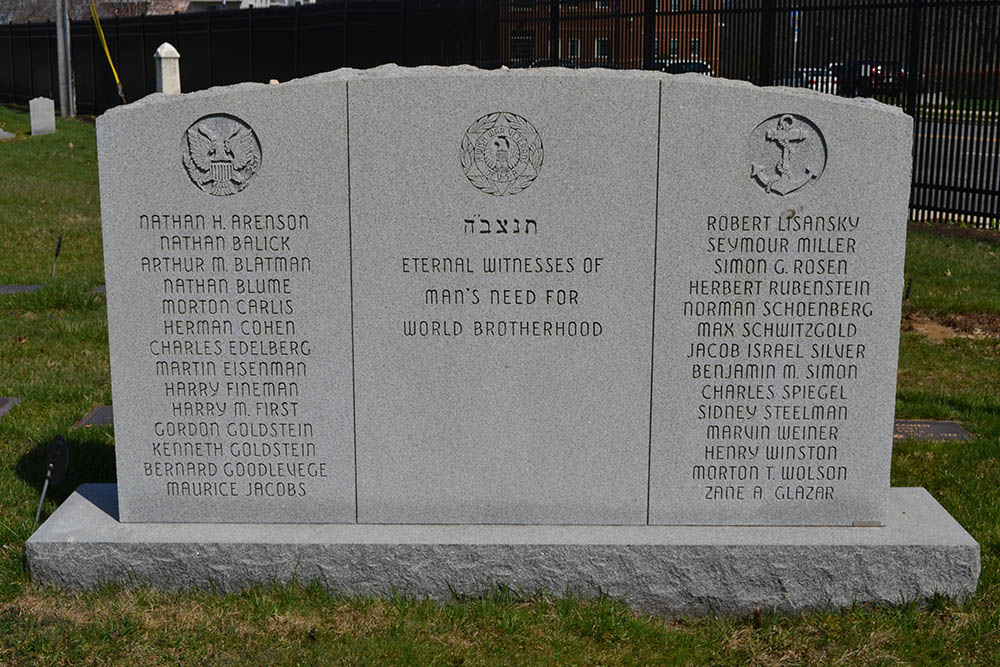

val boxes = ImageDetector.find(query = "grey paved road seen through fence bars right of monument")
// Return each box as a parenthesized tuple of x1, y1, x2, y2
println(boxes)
(913, 118, 1000, 217)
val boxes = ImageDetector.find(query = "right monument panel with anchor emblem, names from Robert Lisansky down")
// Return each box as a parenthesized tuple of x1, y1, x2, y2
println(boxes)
(649, 77, 911, 525)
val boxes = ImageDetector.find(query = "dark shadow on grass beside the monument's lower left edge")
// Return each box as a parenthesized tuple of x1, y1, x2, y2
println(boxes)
(14, 427, 116, 504)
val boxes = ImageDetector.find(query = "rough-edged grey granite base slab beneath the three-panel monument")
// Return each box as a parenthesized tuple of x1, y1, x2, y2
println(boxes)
(26, 484, 980, 615)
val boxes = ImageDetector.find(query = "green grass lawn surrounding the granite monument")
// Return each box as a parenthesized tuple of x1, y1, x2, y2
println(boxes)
(0, 107, 1000, 665)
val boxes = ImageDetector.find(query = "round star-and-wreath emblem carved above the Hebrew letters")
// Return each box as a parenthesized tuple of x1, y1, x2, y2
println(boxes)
(460, 111, 543, 197)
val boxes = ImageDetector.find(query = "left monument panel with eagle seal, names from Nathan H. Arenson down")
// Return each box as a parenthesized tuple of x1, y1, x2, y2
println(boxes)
(98, 81, 356, 523)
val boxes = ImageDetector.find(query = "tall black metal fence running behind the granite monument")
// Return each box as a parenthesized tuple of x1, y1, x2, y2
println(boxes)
(0, 0, 1000, 227)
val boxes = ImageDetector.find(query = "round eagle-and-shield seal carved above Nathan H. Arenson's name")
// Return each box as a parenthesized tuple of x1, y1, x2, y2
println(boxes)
(181, 114, 261, 197)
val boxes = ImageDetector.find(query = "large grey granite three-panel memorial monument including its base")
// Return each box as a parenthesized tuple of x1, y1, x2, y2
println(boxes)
(29, 67, 979, 612)
